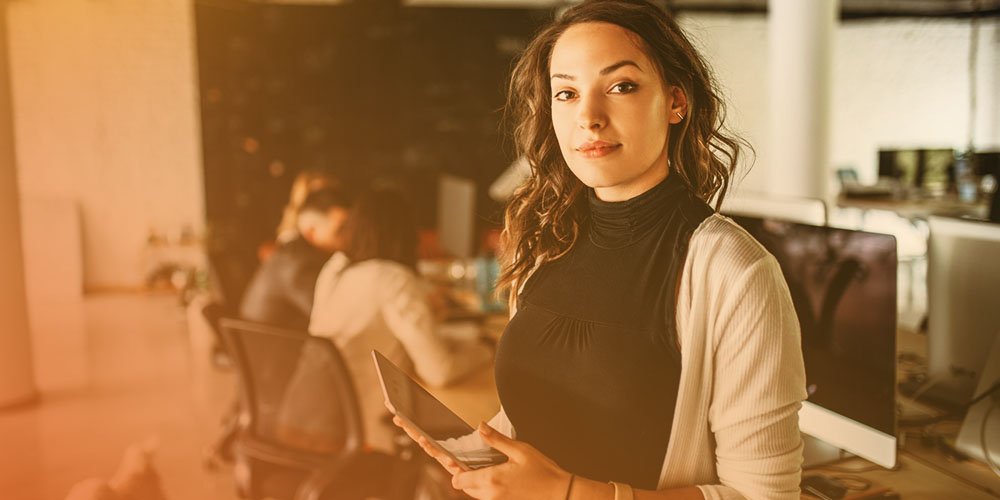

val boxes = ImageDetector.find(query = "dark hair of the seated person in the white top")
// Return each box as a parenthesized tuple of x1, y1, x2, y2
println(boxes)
(340, 189, 417, 269)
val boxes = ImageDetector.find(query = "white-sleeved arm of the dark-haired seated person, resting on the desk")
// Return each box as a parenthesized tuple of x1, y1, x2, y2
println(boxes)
(382, 272, 493, 387)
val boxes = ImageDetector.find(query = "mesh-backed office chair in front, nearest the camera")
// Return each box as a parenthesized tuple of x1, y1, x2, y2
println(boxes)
(220, 319, 422, 500)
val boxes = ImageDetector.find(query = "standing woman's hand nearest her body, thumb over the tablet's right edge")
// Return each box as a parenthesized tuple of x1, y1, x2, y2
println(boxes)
(451, 423, 570, 500)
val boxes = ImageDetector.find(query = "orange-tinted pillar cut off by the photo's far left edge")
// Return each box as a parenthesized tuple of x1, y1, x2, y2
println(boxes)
(0, 5, 36, 408)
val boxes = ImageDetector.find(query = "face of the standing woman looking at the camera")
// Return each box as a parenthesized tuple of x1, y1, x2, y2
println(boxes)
(549, 23, 687, 201)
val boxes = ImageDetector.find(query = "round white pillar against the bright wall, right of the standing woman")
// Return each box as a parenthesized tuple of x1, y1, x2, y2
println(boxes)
(768, 0, 839, 199)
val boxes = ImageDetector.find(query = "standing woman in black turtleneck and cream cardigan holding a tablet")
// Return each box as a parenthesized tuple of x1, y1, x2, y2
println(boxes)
(397, 0, 805, 499)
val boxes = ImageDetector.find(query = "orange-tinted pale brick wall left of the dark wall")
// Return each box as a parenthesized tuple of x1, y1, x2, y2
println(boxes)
(5, 0, 204, 289)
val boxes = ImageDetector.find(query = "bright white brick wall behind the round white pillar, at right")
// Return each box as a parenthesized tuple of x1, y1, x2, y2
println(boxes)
(681, 14, 1000, 191)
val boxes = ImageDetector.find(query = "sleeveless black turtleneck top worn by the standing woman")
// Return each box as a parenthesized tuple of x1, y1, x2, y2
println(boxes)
(496, 174, 712, 489)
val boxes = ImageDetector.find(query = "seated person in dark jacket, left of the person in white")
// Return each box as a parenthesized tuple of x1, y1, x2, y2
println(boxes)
(240, 189, 348, 331)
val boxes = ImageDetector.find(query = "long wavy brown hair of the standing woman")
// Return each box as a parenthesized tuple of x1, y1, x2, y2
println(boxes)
(497, 0, 749, 305)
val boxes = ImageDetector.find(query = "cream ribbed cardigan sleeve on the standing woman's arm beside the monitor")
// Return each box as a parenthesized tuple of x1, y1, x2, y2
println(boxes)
(700, 255, 806, 500)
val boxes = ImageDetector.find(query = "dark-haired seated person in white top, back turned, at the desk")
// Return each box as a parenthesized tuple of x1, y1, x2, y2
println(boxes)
(309, 190, 492, 451)
